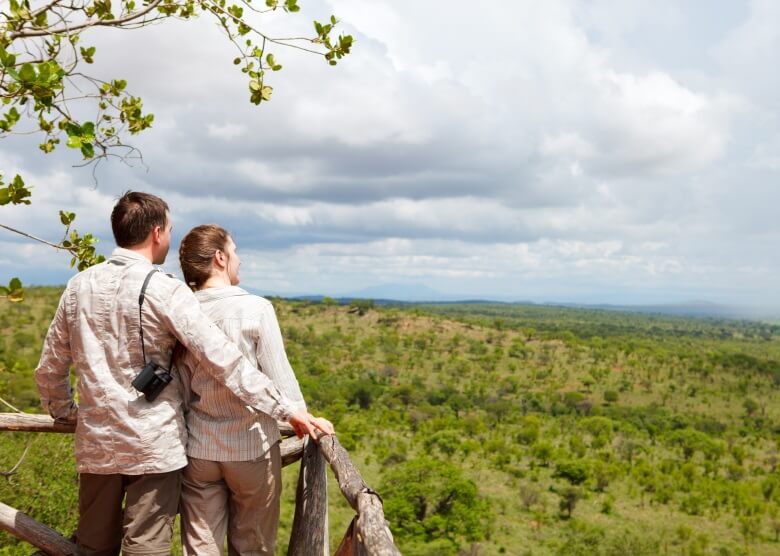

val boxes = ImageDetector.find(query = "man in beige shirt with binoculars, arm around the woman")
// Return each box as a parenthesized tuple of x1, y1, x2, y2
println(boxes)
(35, 192, 333, 556)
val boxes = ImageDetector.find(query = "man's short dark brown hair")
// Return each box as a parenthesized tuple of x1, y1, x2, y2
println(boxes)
(111, 191, 168, 247)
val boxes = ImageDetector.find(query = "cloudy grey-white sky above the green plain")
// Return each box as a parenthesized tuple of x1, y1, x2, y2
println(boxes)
(0, 0, 780, 306)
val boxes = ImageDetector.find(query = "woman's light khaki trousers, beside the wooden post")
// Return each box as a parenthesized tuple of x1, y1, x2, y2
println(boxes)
(181, 442, 282, 556)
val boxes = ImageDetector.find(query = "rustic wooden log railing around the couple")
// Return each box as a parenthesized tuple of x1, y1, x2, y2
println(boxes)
(0, 413, 401, 556)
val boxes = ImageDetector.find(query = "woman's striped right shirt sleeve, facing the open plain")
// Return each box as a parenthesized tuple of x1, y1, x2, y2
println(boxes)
(256, 301, 306, 411)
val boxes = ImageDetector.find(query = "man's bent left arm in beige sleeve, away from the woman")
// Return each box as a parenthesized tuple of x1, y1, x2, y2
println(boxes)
(35, 289, 78, 422)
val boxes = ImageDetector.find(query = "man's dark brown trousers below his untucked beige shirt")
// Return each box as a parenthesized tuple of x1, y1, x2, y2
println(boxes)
(76, 469, 181, 556)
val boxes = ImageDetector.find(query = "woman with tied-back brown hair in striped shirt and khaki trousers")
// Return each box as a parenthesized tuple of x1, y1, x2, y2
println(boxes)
(179, 225, 332, 556)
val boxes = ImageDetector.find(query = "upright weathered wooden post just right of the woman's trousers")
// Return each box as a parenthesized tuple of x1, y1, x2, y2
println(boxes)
(287, 437, 330, 556)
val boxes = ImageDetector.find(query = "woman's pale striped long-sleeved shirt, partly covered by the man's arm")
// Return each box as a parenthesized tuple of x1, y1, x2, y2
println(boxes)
(177, 286, 306, 461)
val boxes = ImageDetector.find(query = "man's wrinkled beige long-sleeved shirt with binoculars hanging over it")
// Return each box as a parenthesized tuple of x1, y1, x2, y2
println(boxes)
(35, 248, 296, 475)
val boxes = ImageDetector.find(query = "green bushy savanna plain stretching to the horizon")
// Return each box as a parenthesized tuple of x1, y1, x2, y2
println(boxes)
(0, 288, 780, 556)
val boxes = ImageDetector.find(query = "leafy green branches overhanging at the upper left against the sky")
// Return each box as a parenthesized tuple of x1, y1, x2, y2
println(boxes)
(0, 0, 353, 299)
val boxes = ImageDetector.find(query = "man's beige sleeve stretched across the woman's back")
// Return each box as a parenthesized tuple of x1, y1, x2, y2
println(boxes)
(160, 283, 297, 422)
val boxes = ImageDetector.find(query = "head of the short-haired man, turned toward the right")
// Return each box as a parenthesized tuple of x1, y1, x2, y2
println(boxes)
(111, 191, 173, 264)
